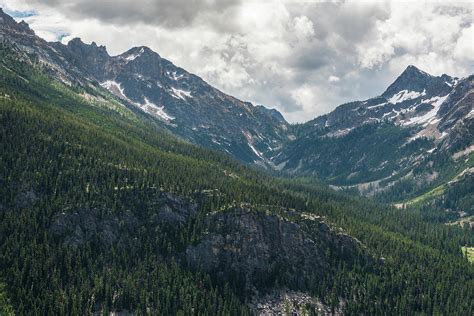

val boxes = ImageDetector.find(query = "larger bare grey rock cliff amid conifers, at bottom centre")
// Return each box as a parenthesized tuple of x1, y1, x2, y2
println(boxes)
(186, 206, 360, 294)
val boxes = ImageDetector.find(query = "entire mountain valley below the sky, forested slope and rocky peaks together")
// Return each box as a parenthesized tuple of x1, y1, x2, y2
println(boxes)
(0, 11, 474, 315)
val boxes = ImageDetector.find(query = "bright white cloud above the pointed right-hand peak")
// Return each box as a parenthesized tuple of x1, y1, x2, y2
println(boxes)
(356, 1, 474, 75)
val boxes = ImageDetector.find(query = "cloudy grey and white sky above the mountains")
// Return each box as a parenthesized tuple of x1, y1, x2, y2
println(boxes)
(0, 0, 474, 123)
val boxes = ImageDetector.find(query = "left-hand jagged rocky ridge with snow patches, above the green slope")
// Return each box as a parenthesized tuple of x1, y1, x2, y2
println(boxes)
(0, 11, 289, 165)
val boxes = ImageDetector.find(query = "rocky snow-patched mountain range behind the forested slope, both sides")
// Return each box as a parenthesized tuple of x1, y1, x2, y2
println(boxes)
(0, 6, 474, 207)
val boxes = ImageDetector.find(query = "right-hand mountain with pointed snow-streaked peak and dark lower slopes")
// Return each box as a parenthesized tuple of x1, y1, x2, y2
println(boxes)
(272, 66, 474, 214)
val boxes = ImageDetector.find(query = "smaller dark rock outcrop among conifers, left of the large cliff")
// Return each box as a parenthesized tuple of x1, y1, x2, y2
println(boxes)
(50, 191, 197, 249)
